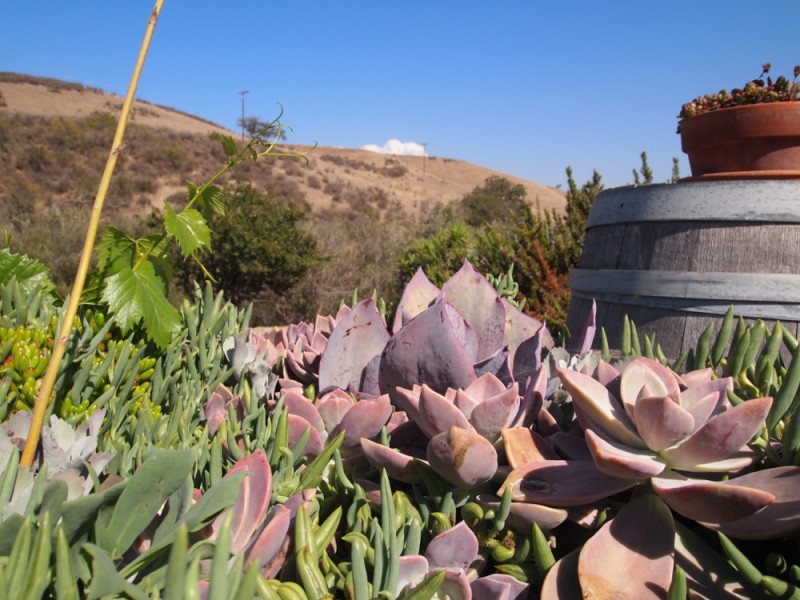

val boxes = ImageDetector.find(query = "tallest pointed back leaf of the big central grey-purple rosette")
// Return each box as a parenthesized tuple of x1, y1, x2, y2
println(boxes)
(442, 260, 506, 362)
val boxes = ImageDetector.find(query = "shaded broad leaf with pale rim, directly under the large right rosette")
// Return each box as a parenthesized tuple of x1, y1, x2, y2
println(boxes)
(652, 477, 775, 523)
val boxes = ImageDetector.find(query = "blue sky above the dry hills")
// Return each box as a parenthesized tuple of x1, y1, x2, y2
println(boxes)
(0, 0, 800, 187)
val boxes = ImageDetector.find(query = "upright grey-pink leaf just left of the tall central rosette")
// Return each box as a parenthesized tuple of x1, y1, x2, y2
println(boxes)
(319, 298, 390, 395)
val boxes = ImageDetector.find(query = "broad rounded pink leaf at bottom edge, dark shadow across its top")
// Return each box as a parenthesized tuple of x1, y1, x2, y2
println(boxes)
(578, 494, 675, 600)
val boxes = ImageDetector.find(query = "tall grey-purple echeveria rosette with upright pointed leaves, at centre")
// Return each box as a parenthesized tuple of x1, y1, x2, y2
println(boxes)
(379, 261, 552, 397)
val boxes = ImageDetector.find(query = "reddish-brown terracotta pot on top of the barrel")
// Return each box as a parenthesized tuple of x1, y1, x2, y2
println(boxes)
(680, 101, 800, 181)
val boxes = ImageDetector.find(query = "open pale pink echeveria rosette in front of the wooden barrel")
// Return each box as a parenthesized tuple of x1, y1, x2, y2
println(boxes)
(556, 358, 772, 480)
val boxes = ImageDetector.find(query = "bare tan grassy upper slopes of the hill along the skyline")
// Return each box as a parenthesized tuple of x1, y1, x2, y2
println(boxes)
(0, 73, 565, 212)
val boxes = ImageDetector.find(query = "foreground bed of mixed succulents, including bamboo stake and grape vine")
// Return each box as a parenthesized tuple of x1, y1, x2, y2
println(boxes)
(0, 5, 800, 600)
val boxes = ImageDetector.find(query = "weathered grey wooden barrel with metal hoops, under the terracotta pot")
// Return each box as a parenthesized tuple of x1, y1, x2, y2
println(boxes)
(567, 180, 800, 357)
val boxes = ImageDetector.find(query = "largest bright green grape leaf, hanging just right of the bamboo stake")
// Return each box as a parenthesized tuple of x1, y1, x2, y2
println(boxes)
(103, 260, 181, 348)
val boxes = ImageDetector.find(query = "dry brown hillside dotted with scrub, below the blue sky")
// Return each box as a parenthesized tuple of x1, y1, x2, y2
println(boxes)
(0, 73, 566, 324)
